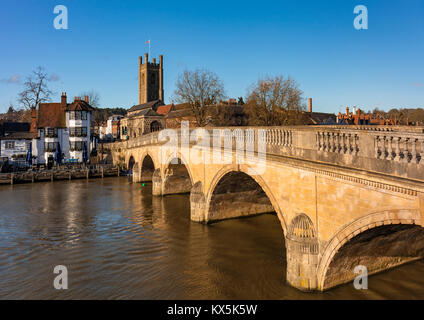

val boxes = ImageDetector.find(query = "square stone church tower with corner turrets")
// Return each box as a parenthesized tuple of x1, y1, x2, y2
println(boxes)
(138, 53, 164, 104)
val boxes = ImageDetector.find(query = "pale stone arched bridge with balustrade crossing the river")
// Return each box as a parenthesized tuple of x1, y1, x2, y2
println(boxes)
(104, 126, 424, 291)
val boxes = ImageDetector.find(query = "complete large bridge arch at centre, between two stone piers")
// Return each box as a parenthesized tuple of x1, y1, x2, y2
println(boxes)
(205, 165, 287, 229)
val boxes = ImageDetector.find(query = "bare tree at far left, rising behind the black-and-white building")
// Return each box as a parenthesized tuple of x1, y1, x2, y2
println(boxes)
(18, 67, 52, 110)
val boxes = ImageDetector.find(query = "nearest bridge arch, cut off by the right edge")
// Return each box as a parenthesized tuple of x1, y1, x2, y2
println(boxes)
(317, 209, 424, 291)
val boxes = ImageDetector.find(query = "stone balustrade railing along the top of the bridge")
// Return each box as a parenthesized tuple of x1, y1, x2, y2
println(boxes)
(103, 126, 424, 180)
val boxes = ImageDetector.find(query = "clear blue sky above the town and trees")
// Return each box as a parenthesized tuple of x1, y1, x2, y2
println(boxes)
(0, 0, 424, 113)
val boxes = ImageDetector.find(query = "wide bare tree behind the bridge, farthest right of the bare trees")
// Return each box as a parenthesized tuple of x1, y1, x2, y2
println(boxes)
(245, 76, 305, 126)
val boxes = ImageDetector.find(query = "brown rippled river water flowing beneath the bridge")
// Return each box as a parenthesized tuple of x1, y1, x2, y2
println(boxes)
(0, 178, 424, 299)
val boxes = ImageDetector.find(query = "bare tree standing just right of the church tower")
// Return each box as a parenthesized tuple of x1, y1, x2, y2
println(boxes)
(175, 69, 225, 127)
